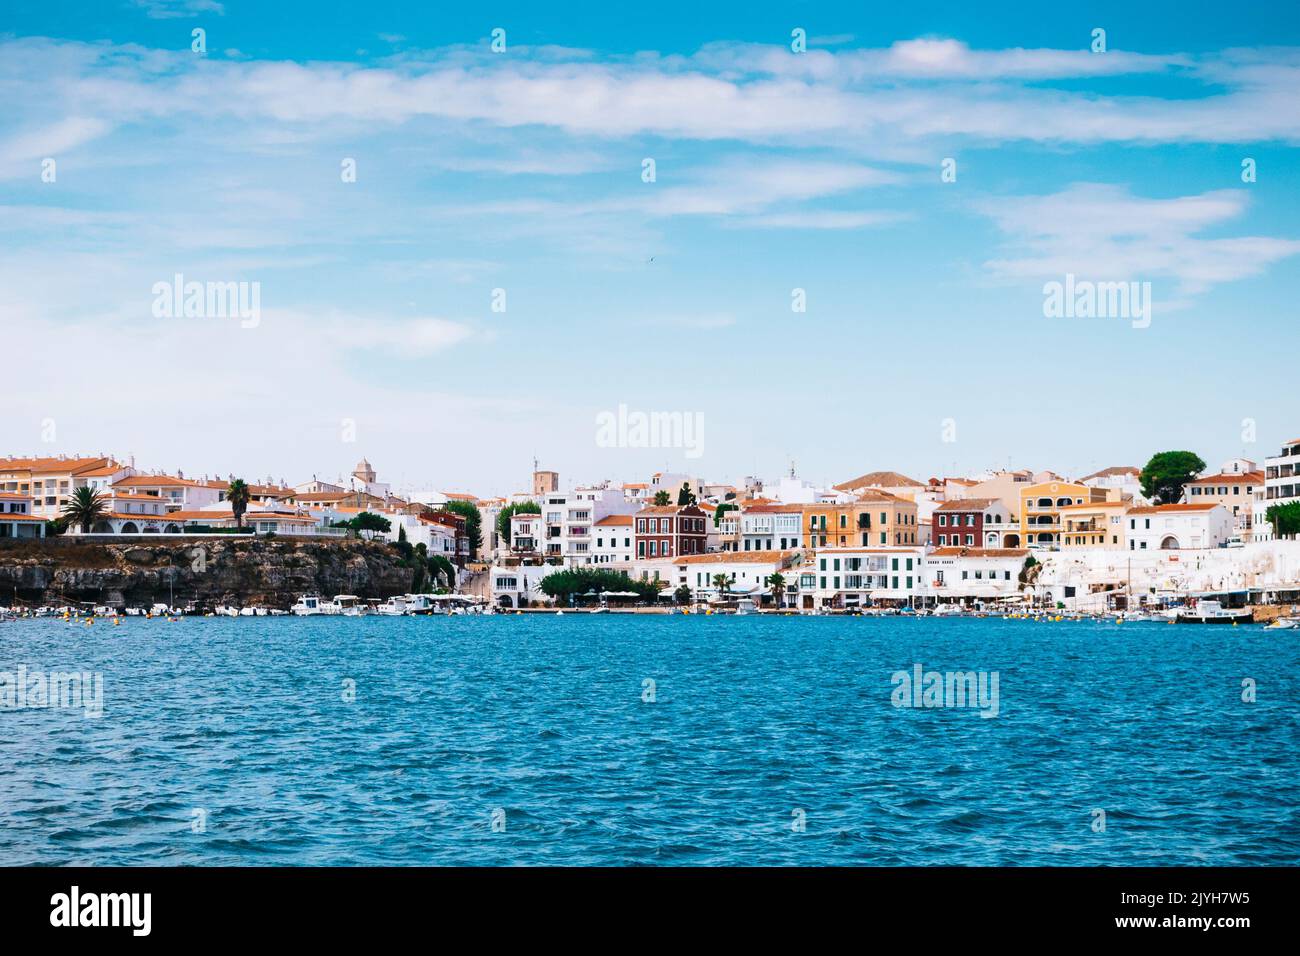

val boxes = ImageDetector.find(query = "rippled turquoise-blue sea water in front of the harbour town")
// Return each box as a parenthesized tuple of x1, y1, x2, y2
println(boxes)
(0, 615, 1300, 865)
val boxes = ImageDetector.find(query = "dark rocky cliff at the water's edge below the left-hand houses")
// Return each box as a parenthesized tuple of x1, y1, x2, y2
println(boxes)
(0, 537, 415, 607)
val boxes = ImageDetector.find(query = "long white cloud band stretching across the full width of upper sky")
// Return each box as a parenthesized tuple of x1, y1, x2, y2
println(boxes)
(0, 39, 1300, 152)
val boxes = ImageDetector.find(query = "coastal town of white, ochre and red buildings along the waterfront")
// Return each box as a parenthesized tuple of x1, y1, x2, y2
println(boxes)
(0, 438, 1300, 615)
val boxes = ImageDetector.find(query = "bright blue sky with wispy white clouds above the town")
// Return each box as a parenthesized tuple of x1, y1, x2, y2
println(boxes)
(0, 0, 1300, 494)
